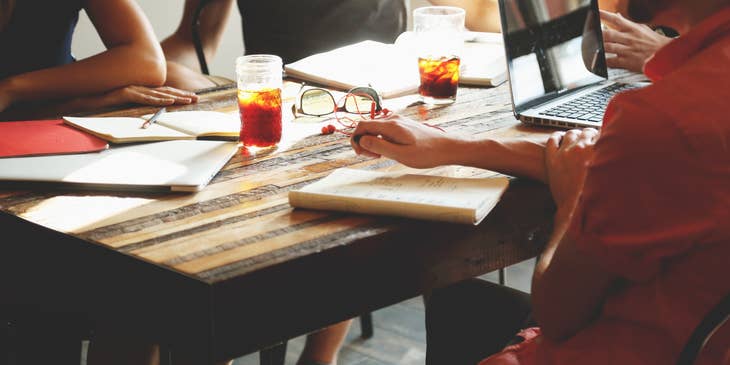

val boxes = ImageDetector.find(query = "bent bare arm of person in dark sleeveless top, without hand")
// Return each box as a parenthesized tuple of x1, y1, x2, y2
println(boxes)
(0, 0, 165, 109)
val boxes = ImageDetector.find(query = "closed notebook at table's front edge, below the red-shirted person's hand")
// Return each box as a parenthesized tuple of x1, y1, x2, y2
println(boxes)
(289, 168, 509, 225)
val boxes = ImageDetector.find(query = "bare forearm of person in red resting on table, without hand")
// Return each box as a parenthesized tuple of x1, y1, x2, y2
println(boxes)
(447, 138, 547, 182)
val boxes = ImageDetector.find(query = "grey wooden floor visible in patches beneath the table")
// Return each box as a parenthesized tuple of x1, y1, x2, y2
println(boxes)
(234, 260, 535, 365)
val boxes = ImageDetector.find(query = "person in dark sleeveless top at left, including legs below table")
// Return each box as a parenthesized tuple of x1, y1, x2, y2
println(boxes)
(0, 0, 197, 365)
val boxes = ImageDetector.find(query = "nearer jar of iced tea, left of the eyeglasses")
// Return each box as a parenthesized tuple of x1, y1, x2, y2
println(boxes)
(236, 55, 282, 147)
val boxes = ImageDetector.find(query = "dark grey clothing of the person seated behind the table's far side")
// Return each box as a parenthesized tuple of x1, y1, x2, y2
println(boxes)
(238, 0, 407, 63)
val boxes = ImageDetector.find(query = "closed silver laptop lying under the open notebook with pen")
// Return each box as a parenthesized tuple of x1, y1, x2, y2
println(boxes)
(0, 140, 238, 192)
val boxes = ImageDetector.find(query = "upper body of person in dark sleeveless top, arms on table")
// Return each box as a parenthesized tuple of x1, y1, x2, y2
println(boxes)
(0, 0, 197, 118)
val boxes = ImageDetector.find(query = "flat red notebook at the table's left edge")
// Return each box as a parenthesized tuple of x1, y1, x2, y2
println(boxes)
(0, 119, 109, 157)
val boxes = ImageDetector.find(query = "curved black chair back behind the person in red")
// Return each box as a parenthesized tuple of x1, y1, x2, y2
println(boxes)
(677, 293, 730, 365)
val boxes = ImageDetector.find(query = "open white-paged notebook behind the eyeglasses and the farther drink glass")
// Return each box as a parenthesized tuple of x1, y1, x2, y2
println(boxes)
(284, 32, 507, 98)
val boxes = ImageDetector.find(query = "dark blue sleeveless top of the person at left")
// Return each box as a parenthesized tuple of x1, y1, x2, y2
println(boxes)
(0, 0, 82, 79)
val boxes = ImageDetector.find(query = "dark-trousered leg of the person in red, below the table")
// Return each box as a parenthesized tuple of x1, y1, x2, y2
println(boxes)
(426, 279, 531, 365)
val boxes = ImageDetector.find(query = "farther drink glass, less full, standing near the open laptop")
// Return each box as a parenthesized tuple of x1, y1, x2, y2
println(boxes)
(413, 6, 466, 104)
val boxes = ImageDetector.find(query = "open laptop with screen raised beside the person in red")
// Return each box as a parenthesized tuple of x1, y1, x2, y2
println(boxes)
(499, 0, 646, 128)
